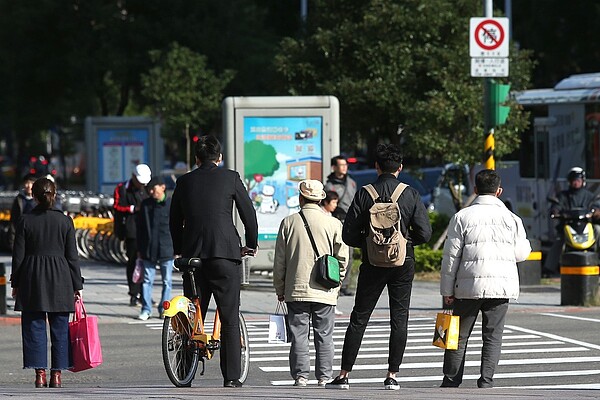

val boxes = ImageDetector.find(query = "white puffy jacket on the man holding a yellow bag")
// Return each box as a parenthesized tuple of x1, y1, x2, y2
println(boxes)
(440, 195, 531, 299)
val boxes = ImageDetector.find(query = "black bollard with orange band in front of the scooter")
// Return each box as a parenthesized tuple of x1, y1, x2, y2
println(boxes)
(560, 251, 600, 306)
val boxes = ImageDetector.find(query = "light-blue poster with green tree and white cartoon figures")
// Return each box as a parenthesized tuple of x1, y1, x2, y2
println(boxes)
(243, 116, 323, 242)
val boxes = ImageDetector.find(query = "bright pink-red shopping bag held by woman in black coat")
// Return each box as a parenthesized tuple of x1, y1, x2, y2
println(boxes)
(69, 297, 102, 372)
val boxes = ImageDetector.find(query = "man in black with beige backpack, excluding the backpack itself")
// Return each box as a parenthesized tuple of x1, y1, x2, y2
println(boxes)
(326, 144, 431, 390)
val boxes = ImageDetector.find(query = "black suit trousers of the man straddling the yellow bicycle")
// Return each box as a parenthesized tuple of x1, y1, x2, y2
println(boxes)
(183, 258, 242, 381)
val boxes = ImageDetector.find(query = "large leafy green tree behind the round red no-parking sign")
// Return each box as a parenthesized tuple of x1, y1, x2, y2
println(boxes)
(276, 0, 532, 163)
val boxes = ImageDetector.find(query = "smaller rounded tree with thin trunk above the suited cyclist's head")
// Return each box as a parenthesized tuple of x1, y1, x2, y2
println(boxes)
(142, 43, 234, 166)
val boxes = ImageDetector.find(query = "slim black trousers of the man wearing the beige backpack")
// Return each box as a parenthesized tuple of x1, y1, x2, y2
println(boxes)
(342, 259, 415, 372)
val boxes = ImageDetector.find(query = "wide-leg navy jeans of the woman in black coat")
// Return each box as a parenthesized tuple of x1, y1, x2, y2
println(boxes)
(21, 311, 71, 370)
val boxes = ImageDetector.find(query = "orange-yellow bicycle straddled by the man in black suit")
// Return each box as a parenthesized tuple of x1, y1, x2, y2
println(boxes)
(162, 258, 250, 387)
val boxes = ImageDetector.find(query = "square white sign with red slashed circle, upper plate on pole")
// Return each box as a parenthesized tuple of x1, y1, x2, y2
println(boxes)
(469, 18, 508, 58)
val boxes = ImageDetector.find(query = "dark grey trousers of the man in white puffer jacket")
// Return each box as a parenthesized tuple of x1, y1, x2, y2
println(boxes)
(442, 299, 508, 388)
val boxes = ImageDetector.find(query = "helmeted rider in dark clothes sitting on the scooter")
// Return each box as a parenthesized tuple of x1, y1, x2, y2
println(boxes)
(544, 167, 600, 273)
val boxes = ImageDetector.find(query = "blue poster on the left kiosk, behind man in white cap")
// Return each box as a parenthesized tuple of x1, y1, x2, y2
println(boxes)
(98, 129, 150, 193)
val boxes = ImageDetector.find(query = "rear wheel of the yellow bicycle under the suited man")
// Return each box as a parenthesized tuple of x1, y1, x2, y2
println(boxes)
(162, 313, 199, 387)
